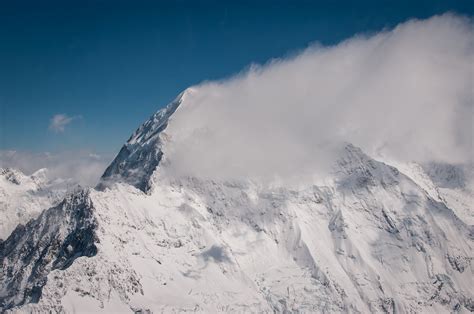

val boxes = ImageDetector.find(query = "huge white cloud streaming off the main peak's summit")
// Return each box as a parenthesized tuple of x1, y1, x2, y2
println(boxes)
(164, 14, 474, 182)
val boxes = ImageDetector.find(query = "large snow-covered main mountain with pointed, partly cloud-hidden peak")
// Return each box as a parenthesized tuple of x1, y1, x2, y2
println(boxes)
(0, 92, 474, 313)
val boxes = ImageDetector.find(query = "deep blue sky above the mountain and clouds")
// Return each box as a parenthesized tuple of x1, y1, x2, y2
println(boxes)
(0, 0, 474, 153)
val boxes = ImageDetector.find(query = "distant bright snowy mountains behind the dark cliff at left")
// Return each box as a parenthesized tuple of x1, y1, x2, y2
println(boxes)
(0, 168, 74, 240)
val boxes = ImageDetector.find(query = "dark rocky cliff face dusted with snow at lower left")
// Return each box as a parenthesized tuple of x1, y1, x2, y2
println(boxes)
(0, 191, 97, 310)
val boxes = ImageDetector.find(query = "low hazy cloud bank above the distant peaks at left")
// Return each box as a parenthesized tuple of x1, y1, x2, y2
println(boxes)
(0, 150, 111, 187)
